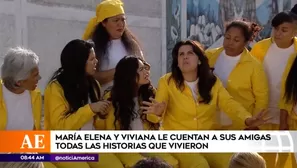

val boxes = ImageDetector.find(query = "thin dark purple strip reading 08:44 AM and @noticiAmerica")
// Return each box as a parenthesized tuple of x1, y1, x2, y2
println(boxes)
(0, 153, 99, 162)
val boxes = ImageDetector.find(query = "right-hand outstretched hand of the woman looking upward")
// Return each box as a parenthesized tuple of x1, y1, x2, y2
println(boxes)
(245, 110, 272, 128)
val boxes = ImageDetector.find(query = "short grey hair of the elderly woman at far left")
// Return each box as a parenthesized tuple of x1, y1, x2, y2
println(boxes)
(1, 47, 39, 89)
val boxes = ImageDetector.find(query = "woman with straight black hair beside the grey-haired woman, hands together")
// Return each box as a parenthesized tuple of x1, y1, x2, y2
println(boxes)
(44, 40, 123, 168)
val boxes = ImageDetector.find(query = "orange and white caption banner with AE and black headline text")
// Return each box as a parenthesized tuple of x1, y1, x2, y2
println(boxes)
(0, 131, 297, 154)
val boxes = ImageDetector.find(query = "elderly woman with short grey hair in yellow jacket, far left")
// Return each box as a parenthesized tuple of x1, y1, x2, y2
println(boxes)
(0, 47, 55, 168)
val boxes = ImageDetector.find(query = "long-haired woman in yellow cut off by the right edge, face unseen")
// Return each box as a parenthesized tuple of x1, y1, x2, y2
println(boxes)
(279, 56, 297, 168)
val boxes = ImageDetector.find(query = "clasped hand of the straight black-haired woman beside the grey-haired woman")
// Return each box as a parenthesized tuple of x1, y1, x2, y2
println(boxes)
(90, 100, 111, 119)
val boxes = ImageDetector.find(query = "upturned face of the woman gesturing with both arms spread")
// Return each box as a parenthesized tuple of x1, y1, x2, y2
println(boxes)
(177, 45, 199, 73)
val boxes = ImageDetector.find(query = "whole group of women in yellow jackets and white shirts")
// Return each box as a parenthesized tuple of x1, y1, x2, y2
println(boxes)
(0, 0, 297, 168)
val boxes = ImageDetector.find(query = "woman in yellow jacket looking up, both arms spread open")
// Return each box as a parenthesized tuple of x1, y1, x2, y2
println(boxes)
(142, 40, 266, 168)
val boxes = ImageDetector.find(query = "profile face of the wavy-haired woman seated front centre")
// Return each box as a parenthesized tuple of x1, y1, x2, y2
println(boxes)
(137, 60, 150, 86)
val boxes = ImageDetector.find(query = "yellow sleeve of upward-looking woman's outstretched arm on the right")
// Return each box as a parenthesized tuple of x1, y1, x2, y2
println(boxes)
(217, 78, 252, 126)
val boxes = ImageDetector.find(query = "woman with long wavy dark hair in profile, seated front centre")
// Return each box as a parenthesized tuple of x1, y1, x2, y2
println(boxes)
(105, 56, 178, 168)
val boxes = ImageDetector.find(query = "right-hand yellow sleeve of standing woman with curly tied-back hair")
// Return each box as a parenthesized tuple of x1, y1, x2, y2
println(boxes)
(252, 62, 269, 115)
